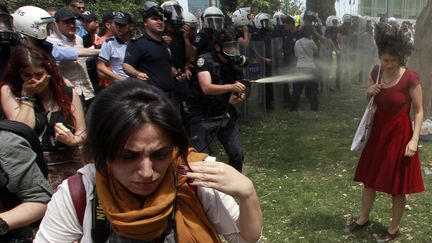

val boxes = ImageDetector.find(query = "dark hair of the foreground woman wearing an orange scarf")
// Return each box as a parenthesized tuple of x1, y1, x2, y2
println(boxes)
(83, 78, 189, 174)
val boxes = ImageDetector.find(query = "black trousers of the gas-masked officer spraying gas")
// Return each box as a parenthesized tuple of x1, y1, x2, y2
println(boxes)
(190, 116, 244, 172)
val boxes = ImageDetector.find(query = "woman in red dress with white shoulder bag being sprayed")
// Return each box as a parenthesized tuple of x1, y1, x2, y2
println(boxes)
(345, 24, 424, 242)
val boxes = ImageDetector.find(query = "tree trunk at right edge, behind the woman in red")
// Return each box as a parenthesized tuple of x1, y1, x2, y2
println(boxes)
(408, 0, 432, 118)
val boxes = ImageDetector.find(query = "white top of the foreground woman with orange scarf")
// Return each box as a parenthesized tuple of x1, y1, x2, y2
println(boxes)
(34, 164, 253, 243)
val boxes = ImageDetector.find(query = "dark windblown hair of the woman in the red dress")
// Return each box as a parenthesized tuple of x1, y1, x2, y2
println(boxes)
(375, 23, 414, 66)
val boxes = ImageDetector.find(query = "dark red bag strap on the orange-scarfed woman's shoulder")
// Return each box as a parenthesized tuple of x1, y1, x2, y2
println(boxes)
(68, 173, 87, 226)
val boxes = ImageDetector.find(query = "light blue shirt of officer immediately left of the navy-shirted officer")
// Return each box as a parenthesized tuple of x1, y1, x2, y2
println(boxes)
(98, 36, 129, 78)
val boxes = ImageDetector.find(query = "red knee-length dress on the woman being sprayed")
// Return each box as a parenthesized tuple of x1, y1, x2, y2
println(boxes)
(354, 69, 424, 195)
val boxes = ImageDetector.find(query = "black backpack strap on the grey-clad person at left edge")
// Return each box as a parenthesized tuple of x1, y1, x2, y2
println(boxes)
(0, 120, 48, 178)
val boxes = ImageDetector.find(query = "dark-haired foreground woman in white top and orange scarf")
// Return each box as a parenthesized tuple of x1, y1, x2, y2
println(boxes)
(35, 79, 263, 243)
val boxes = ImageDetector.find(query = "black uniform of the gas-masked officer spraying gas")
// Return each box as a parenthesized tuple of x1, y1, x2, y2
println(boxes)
(190, 51, 244, 172)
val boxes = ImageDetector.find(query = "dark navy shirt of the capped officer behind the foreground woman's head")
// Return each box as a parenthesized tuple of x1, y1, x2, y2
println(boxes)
(124, 33, 174, 93)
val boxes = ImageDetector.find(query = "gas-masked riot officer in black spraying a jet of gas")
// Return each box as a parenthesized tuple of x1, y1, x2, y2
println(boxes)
(190, 28, 246, 171)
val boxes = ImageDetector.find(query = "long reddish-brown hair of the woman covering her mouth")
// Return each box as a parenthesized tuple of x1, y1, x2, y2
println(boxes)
(0, 46, 76, 123)
